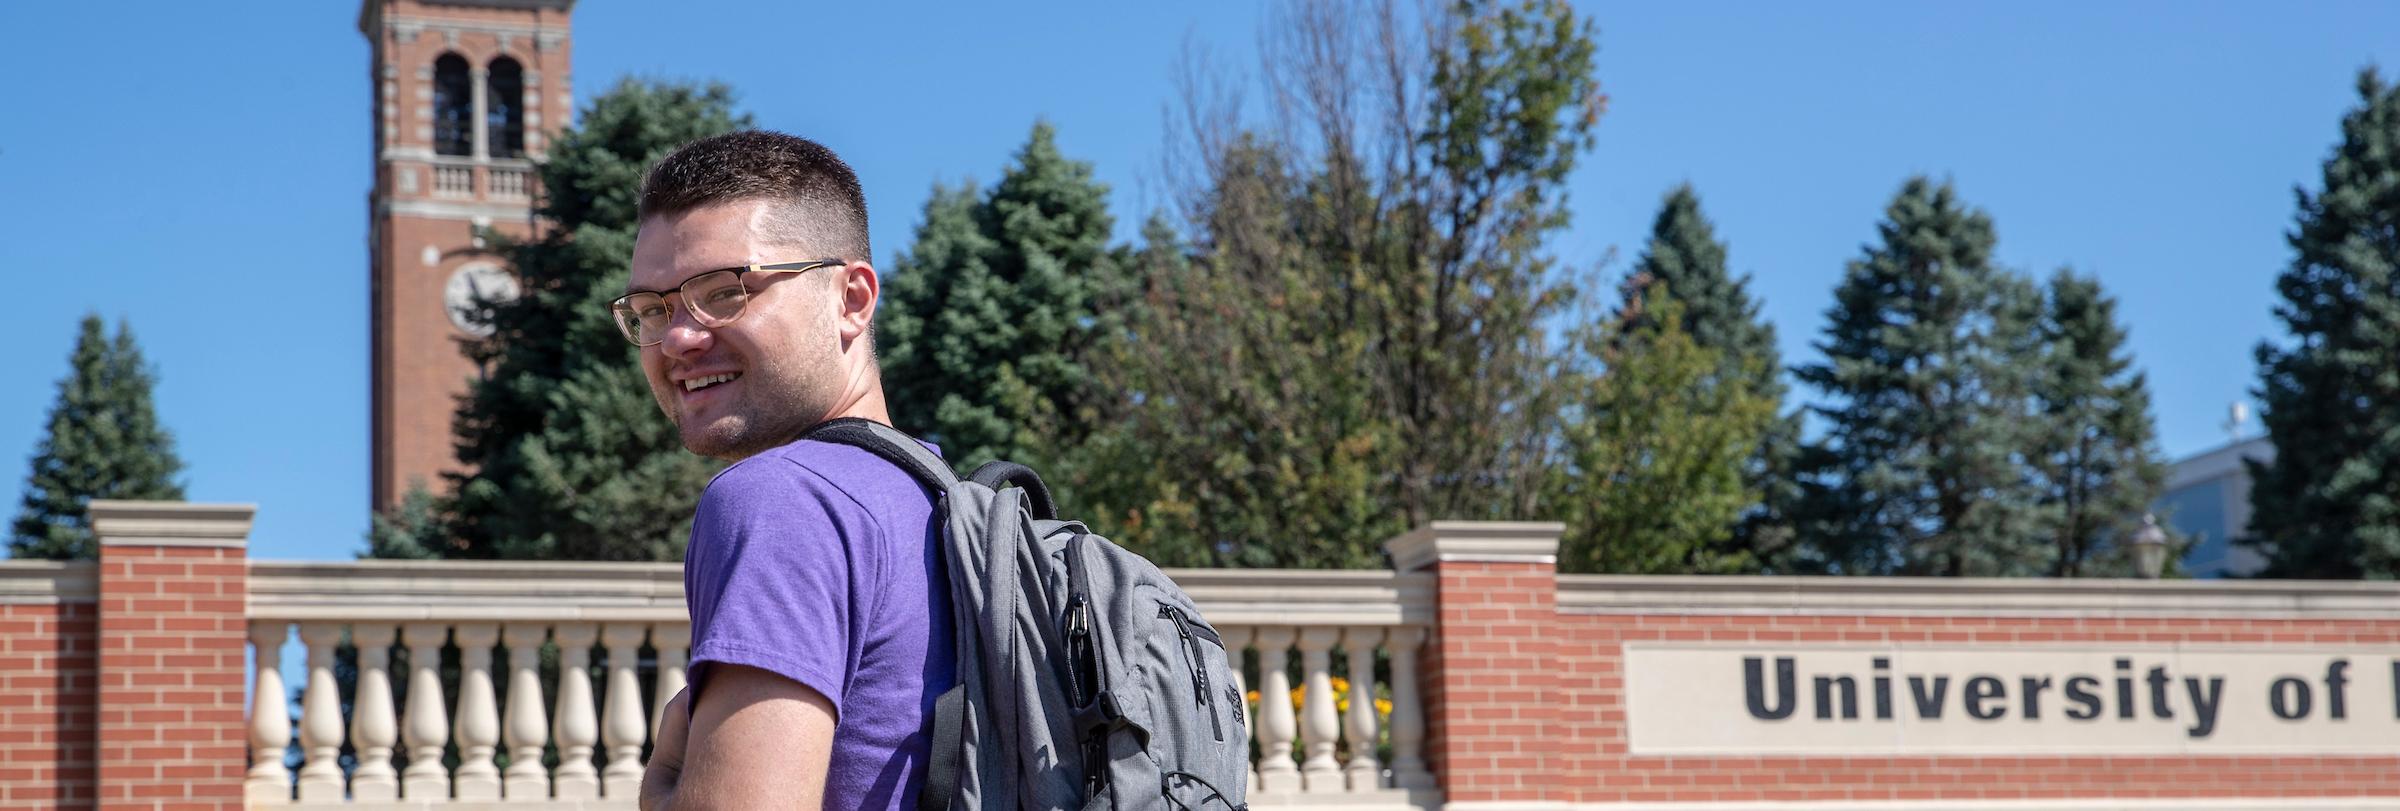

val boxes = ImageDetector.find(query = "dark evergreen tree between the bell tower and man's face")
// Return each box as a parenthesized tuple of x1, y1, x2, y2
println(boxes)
(370, 79, 749, 561)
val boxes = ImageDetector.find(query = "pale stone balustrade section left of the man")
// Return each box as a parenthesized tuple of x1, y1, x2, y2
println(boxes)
(245, 561, 691, 809)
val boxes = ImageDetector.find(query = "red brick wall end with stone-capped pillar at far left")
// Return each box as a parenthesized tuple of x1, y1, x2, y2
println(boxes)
(0, 501, 252, 809)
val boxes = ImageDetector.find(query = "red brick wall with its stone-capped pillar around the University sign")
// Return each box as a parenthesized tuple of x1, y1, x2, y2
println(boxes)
(1390, 523, 2400, 809)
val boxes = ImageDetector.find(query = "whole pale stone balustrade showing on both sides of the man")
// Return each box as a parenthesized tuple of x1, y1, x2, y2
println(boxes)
(245, 561, 1440, 809)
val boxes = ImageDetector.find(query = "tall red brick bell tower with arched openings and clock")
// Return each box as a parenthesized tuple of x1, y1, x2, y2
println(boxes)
(358, 0, 574, 511)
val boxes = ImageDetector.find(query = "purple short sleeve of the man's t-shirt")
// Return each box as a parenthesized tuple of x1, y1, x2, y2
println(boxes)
(684, 458, 876, 713)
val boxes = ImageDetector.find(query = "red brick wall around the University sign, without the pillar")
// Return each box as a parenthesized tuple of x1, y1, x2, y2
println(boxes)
(1548, 614, 2400, 801)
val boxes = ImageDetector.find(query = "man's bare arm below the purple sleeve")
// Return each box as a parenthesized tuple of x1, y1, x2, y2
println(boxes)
(641, 665, 835, 811)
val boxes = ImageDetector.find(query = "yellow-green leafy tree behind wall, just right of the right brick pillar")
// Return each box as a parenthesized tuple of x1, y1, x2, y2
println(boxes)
(1543, 274, 1778, 573)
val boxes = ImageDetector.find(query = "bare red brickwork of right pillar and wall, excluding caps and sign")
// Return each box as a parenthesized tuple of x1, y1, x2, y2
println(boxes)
(1488, 604, 2400, 801)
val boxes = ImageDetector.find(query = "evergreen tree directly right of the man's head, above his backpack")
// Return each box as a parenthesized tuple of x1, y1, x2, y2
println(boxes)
(876, 125, 1123, 470)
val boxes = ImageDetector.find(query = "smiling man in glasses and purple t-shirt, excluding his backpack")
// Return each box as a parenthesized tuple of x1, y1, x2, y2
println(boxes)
(628, 132, 955, 811)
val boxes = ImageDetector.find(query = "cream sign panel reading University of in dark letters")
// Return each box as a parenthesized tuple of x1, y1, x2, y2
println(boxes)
(1625, 643, 2400, 756)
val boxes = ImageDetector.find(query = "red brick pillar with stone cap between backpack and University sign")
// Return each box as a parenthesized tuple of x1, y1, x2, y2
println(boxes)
(1385, 521, 1565, 806)
